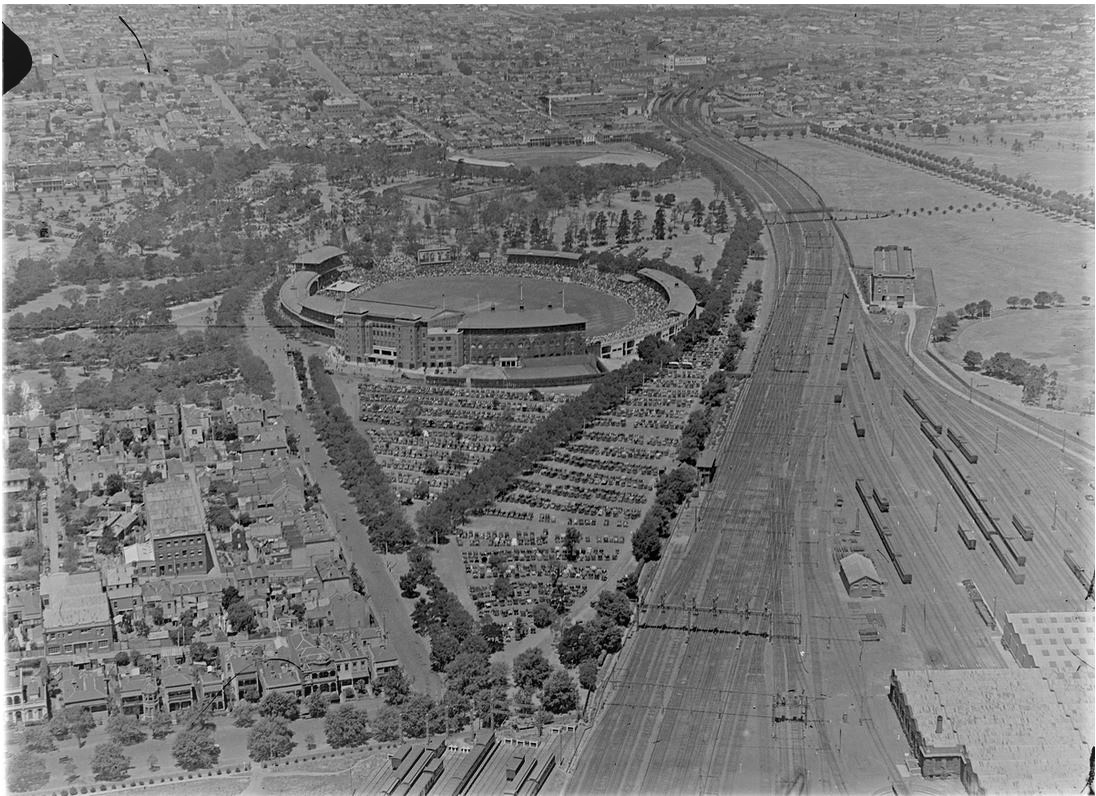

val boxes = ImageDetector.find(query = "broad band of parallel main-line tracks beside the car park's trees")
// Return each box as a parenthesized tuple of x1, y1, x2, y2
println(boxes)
(569, 94, 840, 793)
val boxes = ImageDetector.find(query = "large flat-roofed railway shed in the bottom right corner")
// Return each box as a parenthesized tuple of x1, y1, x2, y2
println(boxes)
(889, 669, 1093, 794)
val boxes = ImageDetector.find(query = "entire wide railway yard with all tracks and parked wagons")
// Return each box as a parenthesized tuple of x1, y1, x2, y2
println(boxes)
(562, 98, 1094, 794)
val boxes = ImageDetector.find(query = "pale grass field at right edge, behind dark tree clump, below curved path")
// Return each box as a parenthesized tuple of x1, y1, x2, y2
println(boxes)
(938, 308, 1096, 411)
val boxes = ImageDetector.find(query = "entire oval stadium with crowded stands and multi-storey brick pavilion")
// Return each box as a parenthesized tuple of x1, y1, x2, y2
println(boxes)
(279, 252, 697, 370)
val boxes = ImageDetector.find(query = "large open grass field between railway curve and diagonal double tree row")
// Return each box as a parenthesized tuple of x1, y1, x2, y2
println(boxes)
(754, 138, 1094, 308)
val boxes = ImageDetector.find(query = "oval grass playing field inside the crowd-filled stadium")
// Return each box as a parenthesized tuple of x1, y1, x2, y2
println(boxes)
(357, 274, 636, 338)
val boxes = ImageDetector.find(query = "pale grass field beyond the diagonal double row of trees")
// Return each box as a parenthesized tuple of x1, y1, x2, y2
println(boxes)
(880, 120, 1096, 198)
